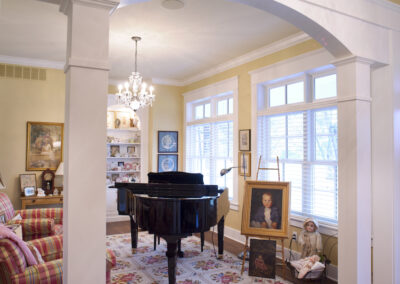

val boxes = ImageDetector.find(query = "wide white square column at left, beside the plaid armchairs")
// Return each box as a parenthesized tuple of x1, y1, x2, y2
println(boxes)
(61, 0, 119, 284)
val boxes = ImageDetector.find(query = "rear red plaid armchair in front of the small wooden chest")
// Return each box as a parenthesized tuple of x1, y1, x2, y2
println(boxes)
(0, 192, 63, 241)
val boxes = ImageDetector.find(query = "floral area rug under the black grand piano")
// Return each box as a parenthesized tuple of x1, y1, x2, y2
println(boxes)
(107, 232, 290, 284)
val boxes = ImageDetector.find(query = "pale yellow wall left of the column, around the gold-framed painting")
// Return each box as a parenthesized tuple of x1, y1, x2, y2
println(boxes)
(0, 69, 65, 208)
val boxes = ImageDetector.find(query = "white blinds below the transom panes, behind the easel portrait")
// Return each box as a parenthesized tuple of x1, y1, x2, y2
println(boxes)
(257, 107, 338, 223)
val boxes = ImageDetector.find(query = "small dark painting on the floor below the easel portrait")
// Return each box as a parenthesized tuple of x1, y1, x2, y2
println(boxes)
(249, 239, 276, 279)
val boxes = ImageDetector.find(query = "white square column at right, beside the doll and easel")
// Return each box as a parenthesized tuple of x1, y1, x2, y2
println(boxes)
(334, 57, 372, 284)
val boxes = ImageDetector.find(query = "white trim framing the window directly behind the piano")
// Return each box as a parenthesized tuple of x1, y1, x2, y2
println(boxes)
(182, 76, 239, 211)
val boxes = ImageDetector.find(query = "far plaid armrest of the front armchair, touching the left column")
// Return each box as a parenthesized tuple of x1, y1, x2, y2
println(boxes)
(28, 235, 63, 261)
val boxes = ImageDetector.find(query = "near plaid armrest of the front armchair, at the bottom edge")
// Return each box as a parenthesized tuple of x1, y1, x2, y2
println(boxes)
(11, 259, 63, 284)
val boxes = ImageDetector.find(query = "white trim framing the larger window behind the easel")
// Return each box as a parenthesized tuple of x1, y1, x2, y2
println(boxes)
(249, 49, 339, 235)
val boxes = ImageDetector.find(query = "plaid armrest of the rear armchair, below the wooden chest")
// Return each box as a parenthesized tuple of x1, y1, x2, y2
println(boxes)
(7, 218, 54, 241)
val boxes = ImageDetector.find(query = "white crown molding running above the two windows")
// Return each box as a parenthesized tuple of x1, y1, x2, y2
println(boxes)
(183, 32, 311, 85)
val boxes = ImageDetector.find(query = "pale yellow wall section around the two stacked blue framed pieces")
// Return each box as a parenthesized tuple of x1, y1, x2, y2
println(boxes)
(149, 82, 184, 172)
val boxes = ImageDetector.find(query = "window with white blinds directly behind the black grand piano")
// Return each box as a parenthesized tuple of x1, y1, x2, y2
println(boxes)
(184, 78, 238, 208)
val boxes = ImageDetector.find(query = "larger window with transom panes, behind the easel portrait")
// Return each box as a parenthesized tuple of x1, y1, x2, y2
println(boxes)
(257, 70, 338, 224)
